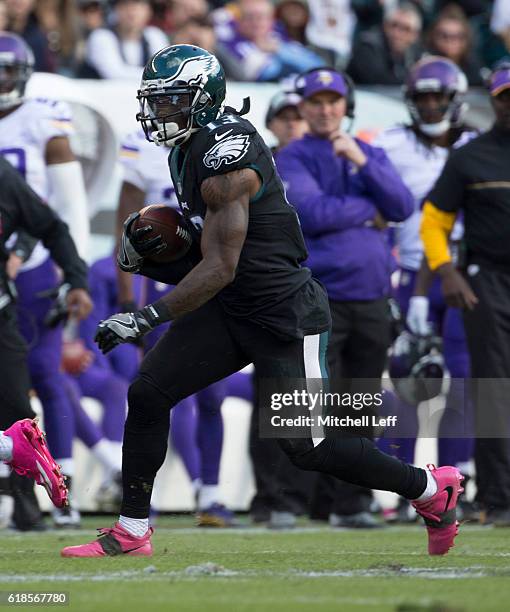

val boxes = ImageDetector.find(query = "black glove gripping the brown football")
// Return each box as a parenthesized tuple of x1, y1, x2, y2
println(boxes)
(117, 213, 166, 274)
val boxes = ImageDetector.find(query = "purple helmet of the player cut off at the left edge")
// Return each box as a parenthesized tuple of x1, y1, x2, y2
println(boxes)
(0, 32, 34, 110)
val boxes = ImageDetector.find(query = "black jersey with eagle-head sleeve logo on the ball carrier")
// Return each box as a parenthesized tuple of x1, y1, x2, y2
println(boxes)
(169, 114, 329, 337)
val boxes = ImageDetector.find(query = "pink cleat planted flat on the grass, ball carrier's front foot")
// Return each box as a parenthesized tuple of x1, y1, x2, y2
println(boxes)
(60, 523, 154, 557)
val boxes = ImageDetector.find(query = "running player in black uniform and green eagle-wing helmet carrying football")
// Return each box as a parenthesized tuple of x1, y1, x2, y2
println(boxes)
(62, 45, 461, 557)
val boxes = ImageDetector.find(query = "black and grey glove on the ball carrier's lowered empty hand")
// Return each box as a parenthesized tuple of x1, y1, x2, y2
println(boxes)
(94, 310, 154, 355)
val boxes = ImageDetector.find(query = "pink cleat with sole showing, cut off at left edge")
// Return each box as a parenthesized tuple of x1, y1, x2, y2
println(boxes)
(4, 419, 67, 508)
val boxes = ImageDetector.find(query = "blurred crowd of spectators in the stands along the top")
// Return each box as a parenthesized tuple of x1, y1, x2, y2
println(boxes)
(0, 0, 510, 86)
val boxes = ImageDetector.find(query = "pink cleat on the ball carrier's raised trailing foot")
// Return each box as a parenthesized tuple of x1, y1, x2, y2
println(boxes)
(412, 465, 464, 555)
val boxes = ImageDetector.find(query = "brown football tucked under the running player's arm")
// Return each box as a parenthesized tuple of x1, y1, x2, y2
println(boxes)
(133, 204, 192, 263)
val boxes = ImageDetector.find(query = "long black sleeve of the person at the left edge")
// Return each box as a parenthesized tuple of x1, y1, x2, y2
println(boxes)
(0, 160, 87, 289)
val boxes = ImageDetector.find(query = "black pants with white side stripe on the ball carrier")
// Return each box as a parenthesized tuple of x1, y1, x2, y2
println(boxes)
(121, 299, 427, 518)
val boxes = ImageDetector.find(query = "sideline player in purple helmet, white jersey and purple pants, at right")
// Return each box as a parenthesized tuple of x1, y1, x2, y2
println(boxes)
(374, 56, 477, 522)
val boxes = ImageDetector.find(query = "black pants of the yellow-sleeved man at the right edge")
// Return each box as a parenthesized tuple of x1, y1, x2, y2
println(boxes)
(464, 266, 510, 510)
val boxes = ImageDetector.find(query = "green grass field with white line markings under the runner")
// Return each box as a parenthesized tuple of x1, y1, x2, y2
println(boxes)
(0, 517, 510, 612)
